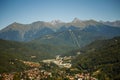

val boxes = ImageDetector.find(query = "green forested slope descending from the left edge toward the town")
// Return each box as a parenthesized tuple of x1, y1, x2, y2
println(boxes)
(0, 39, 70, 73)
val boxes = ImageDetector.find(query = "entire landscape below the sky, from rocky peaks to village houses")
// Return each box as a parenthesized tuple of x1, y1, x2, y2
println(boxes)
(0, 18, 120, 80)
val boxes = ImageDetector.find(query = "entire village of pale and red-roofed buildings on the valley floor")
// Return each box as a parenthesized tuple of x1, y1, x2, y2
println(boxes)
(0, 55, 97, 80)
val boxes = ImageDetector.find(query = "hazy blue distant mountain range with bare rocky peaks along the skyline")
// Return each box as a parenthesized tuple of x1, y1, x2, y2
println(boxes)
(0, 18, 120, 45)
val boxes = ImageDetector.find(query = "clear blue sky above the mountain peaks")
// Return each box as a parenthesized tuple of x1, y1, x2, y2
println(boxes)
(0, 0, 120, 29)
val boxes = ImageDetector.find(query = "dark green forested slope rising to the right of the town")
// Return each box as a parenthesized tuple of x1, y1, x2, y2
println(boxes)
(73, 37, 120, 80)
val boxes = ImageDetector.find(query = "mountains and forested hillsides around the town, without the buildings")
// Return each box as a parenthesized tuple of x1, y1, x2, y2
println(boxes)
(0, 18, 120, 80)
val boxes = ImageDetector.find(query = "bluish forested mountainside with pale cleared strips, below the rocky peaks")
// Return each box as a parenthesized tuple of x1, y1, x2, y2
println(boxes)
(33, 25, 120, 48)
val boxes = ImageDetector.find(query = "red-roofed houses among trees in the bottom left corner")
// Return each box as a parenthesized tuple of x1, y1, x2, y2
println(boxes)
(0, 68, 52, 80)
